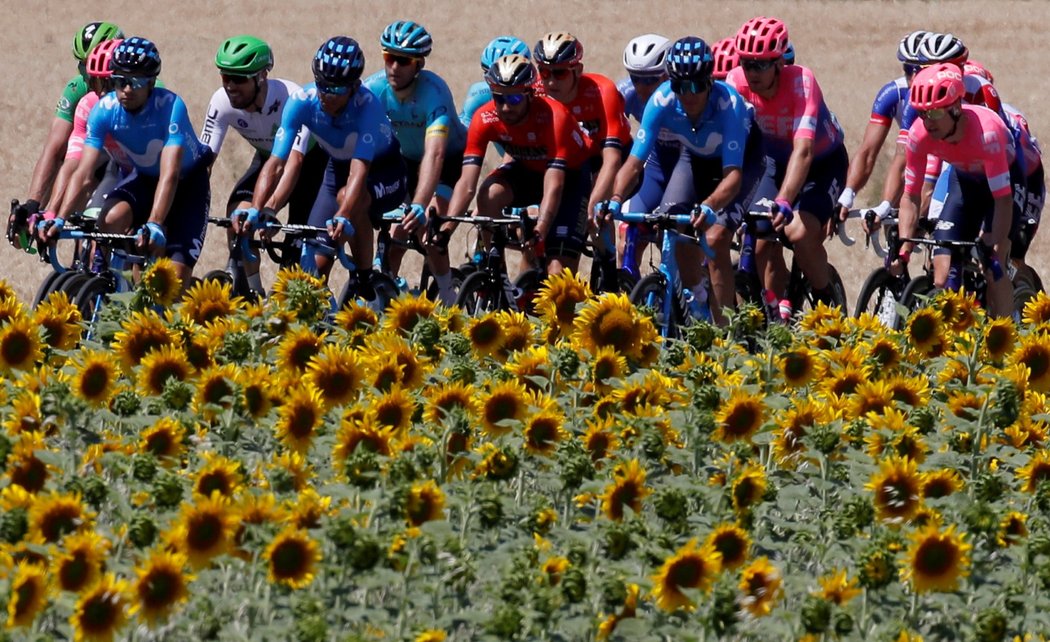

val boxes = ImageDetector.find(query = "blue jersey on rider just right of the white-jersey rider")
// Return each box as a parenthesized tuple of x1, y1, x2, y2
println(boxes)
(272, 83, 397, 163)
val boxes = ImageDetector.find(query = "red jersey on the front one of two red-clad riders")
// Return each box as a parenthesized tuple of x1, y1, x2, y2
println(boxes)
(463, 96, 591, 172)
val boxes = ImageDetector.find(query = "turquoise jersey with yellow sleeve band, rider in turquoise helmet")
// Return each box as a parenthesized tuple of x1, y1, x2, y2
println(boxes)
(364, 69, 466, 161)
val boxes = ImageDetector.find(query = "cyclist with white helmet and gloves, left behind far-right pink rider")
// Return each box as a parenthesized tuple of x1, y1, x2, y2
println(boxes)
(838, 29, 929, 225)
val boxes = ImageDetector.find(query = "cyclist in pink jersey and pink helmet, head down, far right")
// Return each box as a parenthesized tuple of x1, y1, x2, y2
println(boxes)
(895, 63, 1025, 316)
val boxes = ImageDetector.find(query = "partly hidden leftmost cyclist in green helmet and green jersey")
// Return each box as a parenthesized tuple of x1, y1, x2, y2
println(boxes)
(13, 22, 124, 241)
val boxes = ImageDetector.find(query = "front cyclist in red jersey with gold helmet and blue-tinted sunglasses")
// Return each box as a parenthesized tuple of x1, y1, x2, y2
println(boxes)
(445, 55, 591, 274)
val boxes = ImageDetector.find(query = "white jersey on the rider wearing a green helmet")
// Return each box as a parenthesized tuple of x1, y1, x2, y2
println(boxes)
(201, 78, 310, 156)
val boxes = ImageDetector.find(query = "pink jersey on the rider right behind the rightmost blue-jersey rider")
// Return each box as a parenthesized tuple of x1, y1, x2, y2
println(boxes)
(726, 65, 843, 164)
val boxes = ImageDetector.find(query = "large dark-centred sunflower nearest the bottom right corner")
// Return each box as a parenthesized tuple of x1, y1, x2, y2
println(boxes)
(901, 524, 972, 593)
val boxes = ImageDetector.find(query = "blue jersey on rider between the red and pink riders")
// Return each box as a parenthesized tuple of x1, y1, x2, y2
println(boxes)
(631, 81, 754, 167)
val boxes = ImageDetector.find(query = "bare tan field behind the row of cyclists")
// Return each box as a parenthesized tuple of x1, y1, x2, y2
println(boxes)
(0, 0, 1050, 306)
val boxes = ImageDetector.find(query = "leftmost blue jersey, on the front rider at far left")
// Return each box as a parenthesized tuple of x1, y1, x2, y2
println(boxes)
(84, 87, 210, 177)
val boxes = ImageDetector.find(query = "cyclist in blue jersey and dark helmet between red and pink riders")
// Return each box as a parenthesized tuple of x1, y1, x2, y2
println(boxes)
(600, 37, 776, 320)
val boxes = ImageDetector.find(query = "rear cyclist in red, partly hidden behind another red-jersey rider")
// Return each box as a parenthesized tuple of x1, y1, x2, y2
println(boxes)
(532, 32, 631, 218)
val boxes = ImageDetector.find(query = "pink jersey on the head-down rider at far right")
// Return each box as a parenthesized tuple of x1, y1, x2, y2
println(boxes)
(904, 105, 1014, 198)
